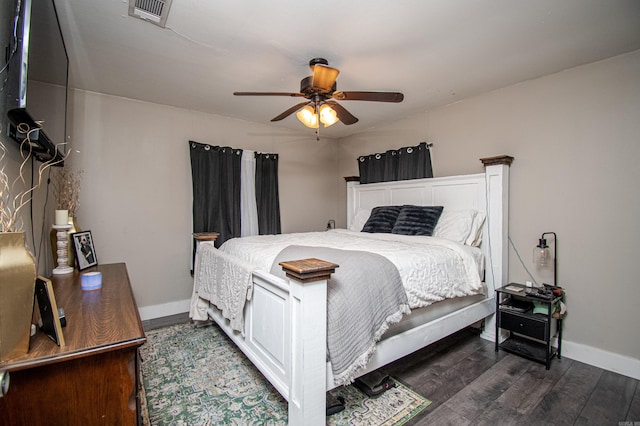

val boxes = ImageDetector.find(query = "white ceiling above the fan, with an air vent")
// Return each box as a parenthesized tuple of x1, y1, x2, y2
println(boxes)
(56, 0, 640, 137)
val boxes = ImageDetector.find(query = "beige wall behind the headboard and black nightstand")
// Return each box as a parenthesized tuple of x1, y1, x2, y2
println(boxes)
(338, 51, 640, 360)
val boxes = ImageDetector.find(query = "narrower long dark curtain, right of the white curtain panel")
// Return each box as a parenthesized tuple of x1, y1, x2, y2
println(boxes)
(255, 153, 281, 235)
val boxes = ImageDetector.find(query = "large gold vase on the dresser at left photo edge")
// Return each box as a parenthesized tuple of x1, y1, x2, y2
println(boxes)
(0, 232, 36, 361)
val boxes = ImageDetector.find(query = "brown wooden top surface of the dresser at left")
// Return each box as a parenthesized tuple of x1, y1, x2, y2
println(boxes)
(0, 263, 146, 371)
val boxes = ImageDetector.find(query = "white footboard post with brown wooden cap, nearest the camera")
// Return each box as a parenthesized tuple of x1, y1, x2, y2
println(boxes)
(280, 259, 338, 426)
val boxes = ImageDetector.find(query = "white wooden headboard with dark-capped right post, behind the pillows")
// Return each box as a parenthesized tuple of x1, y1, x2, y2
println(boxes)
(347, 156, 513, 292)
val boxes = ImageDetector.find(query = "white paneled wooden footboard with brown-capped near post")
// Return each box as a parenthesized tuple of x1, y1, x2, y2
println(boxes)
(208, 259, 338, 425)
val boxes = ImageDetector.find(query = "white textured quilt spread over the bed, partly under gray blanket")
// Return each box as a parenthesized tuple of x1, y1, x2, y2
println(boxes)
(220, 229, 483, 309)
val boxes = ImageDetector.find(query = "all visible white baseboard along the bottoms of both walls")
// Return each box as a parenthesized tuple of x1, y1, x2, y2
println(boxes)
(138, 299, 640, 380)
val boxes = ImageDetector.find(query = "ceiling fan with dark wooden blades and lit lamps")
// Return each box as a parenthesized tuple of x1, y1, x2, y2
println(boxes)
(233, 58, 404, 129)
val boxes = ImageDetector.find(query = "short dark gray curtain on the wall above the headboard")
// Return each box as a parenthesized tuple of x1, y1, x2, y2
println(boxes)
(358, 142, 433, 183)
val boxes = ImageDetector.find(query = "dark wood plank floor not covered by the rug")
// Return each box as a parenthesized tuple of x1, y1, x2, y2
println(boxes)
(143, 314, 640, 426)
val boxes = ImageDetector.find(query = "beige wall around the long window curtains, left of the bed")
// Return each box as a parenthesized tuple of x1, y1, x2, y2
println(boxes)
(71, 91, 337, 313)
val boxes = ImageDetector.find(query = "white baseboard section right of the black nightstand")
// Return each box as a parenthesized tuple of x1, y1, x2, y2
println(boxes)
(562, 340, 640, 380)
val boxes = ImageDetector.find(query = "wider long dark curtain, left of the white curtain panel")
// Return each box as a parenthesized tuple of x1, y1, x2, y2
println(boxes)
(189, 141, 242, 247)
